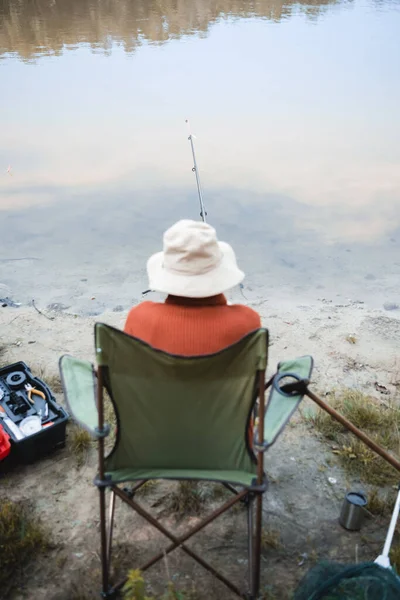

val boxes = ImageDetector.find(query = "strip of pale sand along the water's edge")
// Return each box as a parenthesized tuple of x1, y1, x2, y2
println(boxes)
(0, 298, 400, 398)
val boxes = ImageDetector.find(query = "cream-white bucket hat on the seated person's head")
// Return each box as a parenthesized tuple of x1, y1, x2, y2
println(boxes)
(147, 219, 244, 298)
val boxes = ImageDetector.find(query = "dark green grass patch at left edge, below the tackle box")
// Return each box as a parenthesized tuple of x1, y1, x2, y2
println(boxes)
(0, 499, 48, 597)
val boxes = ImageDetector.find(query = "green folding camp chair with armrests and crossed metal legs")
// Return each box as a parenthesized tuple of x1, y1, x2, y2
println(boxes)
(60, 323, 312, 600)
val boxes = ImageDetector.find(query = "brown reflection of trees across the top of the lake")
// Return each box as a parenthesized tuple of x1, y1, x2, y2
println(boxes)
(0, 0, 342, 60)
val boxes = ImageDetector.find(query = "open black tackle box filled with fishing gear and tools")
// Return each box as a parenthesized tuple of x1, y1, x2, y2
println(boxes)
(0, 361, 68, 471)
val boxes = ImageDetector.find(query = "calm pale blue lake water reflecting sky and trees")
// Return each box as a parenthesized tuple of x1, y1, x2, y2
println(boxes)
(0, 0, 400, 314)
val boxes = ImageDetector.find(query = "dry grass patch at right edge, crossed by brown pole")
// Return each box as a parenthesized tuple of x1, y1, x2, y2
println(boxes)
(307, 390, 400, 486)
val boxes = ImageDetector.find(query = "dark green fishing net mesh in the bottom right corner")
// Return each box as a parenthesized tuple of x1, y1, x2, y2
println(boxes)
(293, 563, 400, 600)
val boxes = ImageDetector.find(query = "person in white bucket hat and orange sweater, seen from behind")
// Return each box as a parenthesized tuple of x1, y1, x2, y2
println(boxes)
(124, 220, 261, 356)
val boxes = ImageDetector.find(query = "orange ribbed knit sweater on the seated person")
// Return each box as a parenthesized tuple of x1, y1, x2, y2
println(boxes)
(124, 294, 261, 356)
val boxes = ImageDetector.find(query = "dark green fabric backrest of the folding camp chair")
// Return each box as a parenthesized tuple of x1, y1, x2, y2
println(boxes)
(95, 323, 268, 472)
